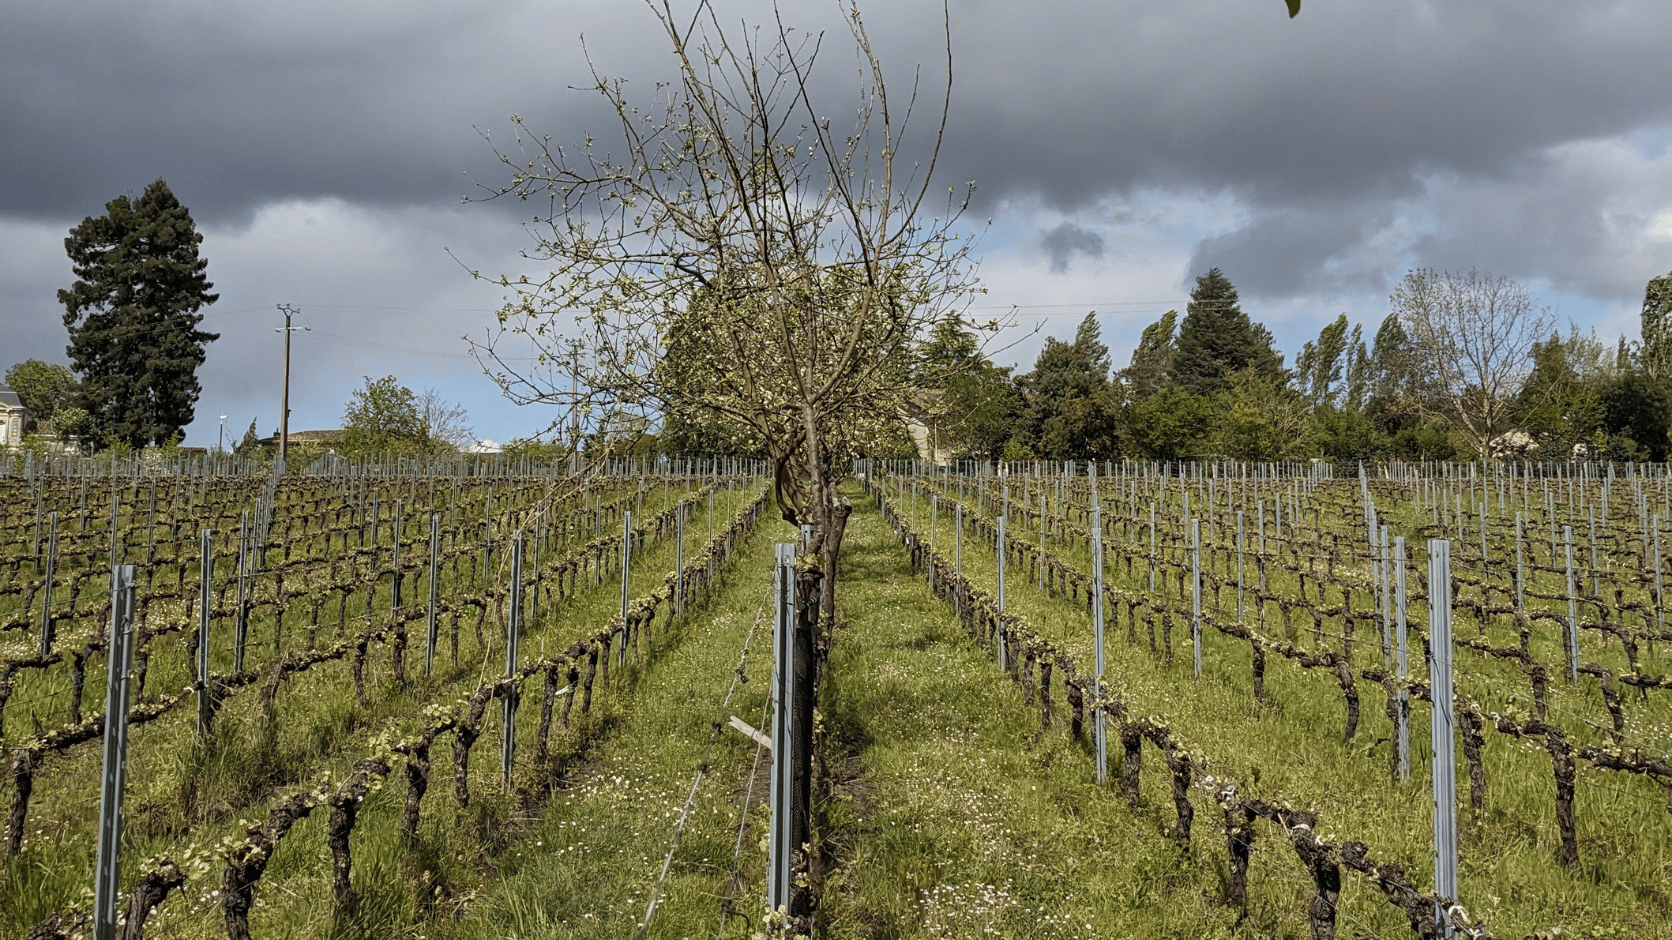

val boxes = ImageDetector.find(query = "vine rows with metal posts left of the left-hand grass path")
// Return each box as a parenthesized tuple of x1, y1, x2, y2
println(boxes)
(0, 454, 762, 937)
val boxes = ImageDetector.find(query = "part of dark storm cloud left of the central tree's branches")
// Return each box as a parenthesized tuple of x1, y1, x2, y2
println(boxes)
(0, 0, 665, 221)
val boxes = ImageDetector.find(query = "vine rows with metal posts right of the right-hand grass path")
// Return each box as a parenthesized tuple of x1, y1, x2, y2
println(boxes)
(874, 467, 1672, 937)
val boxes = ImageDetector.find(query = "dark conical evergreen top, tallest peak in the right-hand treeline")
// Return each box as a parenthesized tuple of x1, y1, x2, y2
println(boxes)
(1172, 268, 1282, 396)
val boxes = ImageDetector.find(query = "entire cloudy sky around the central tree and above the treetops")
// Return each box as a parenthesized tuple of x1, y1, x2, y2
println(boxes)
(0, 0, 1672, 447)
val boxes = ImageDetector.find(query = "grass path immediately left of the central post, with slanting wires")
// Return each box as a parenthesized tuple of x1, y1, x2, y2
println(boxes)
(445, 507, 794, 940)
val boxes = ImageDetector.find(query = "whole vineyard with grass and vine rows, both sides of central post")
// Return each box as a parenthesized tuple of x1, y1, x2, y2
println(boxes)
(0, 460, 1672, 940)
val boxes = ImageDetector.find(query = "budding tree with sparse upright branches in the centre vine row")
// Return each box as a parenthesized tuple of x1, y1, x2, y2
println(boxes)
(477, 0, 990, 602)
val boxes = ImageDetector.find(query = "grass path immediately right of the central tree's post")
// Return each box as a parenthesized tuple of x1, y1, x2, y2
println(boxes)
(821, 497, 1250, 938)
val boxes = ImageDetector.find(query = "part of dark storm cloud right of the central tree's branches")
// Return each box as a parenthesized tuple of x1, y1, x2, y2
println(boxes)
(929, 0, 1672, 206)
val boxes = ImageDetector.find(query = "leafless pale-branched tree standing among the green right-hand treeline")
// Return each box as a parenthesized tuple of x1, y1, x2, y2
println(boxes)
(1391, 268, 1555, 457)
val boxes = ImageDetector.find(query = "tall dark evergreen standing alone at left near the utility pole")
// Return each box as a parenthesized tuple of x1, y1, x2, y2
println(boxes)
(59, 179, 221, 447)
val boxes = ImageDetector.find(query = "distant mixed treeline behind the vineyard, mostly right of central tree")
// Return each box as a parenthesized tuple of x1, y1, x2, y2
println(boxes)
(659, 268, 1672, 463)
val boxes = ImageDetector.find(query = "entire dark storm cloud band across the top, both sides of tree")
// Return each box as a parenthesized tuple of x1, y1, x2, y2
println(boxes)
(13, 0, 1672, 216)
